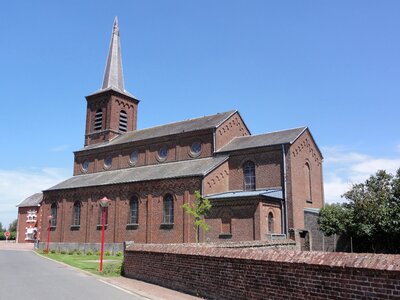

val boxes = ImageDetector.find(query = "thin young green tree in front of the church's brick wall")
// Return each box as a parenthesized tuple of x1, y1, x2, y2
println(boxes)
(181, 191, 211, 243)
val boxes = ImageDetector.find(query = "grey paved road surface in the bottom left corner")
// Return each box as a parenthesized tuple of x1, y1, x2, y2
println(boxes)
(0, 250, 145, 300)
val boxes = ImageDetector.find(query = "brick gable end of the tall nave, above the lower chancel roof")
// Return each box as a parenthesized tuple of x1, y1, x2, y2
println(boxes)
(215, 112, 250, 151)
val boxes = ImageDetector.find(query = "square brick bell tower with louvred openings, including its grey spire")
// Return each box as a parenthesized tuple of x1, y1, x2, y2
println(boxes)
(85, 17, 139, 147)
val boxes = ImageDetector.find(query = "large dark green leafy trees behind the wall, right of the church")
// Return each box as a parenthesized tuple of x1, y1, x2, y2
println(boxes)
(318, 169, 400, 253)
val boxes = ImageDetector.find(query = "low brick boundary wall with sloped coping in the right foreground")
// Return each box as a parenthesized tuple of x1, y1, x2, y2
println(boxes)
(124, 244, 400, 299)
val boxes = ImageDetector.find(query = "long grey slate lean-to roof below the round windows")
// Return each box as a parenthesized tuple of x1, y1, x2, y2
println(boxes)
(47, 155, 228, 191)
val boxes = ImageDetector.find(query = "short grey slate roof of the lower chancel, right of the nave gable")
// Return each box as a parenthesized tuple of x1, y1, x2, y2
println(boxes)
(218, 127, 307, 152)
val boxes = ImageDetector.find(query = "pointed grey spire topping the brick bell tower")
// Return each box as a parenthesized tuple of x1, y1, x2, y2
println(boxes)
(101, 17, 125, 92)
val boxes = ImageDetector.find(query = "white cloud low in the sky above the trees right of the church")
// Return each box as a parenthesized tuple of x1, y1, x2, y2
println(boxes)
(322, 146, 400, 203)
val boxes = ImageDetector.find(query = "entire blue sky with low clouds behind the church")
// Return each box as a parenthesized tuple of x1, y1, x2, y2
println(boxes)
(0, 0, 400, 224)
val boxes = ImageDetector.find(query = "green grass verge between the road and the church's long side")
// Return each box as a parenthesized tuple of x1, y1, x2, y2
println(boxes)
(37, 251, 122, 277)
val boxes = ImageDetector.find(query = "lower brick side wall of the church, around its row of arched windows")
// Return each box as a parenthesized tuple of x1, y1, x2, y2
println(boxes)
(41, 178, 201, 243)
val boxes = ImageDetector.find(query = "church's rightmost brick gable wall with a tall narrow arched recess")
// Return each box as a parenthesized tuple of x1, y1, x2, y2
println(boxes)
(288, 130, 324, 228)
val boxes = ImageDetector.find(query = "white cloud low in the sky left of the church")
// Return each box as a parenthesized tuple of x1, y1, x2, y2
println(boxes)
(0, 168, 69, 226)
